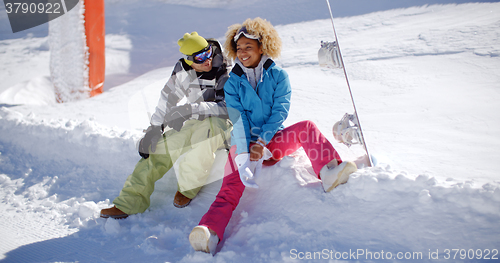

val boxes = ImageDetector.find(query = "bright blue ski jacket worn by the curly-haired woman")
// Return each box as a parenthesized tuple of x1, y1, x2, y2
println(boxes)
(224, 59, 292, 154)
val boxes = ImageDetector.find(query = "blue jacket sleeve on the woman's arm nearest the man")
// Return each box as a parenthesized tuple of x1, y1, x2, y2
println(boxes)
(224, 76, 250, 154)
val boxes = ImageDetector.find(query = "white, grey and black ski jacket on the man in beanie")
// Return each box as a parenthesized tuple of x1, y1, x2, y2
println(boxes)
(151, 39, 230, 126)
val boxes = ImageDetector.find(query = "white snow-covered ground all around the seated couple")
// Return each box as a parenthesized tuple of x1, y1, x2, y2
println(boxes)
(0, 1, 500, 262)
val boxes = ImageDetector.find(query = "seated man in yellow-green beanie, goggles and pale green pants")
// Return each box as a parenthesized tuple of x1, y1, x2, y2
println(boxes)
(101, 32, 232, 218)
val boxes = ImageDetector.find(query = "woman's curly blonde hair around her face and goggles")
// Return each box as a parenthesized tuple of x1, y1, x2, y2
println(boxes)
(224, 17, 281, 59)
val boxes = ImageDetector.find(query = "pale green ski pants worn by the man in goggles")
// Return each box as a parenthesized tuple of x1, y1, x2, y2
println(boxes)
(113, 117, 232, 215)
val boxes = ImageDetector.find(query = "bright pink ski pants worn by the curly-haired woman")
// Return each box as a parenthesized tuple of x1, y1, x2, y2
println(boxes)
(199, 121, 342, 240)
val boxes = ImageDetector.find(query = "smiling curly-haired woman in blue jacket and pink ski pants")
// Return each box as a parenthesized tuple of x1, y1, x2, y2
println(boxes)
(189, 18, 357, 254)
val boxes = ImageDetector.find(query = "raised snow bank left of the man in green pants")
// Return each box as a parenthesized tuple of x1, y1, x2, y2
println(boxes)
(0, 108, 138, 200)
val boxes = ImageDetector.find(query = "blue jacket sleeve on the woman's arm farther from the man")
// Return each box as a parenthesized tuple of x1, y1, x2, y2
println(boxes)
(259, 67, 292, 144)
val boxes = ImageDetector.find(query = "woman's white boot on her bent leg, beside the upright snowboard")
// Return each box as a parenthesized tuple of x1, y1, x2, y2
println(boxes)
(319, 160, 358, 192)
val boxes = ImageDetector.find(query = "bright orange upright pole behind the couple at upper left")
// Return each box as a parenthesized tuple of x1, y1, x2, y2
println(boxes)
(84, 0, 106, 97)
